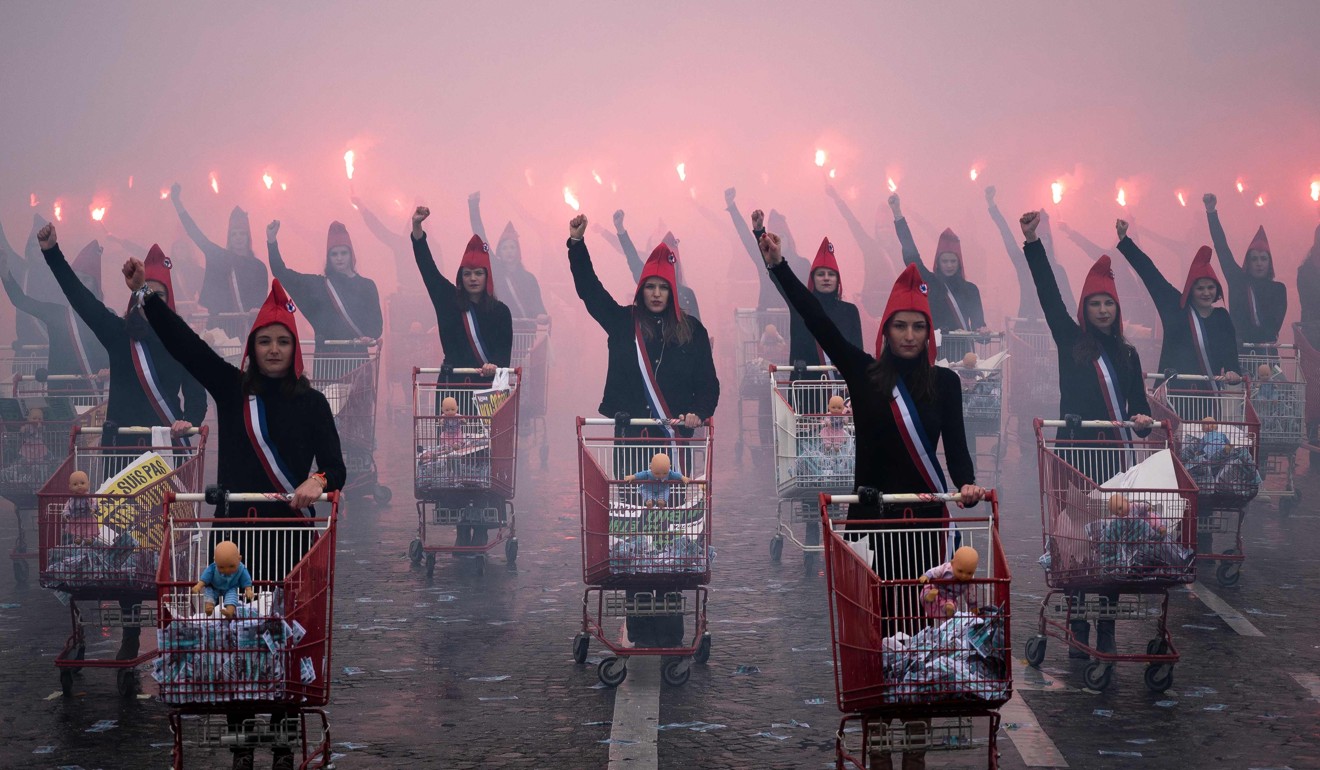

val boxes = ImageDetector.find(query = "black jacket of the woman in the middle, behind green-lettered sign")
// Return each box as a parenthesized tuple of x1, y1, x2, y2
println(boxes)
(568, 239, 719, 419)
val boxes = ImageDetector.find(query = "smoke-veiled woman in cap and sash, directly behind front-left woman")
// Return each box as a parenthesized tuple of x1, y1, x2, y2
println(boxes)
(265, 219, 384, 382)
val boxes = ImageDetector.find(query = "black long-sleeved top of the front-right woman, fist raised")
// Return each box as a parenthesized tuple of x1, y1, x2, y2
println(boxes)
(771, 263, 975, 515)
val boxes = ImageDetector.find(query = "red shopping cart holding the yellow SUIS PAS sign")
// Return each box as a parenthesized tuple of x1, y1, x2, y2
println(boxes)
(37, 427, 209, 696)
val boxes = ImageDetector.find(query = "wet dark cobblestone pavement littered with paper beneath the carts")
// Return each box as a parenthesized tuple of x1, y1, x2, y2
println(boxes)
(0, 404, 1320, 770)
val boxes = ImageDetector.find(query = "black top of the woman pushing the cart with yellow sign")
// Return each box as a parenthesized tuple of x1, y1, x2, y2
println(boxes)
(41, 246, 206, 427)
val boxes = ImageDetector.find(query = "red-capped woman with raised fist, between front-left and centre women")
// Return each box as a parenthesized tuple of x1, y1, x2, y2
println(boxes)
(412, 206, 513, 547)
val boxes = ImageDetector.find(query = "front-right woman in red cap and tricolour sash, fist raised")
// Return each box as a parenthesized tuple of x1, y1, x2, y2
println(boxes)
(760, 232, 986, 769)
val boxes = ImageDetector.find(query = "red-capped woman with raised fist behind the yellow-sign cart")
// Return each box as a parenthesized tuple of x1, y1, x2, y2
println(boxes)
(37, 225, 206, 660)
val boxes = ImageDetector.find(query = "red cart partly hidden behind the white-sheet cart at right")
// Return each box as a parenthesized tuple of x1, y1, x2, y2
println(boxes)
(1150, 375, 1262, 588)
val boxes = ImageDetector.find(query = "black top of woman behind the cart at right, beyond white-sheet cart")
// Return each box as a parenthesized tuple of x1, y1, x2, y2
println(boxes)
(1118, 238, 1242, 375)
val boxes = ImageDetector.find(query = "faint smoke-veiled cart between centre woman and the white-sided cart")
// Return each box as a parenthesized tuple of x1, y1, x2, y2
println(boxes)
(734, 308, 788, 460)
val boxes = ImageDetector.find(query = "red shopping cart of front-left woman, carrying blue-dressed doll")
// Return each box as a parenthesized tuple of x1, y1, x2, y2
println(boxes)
(152, 487, 339, 770)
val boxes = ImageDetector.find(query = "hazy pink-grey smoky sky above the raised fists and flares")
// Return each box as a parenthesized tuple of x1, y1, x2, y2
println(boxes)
(0, 0, 1320, 314)
